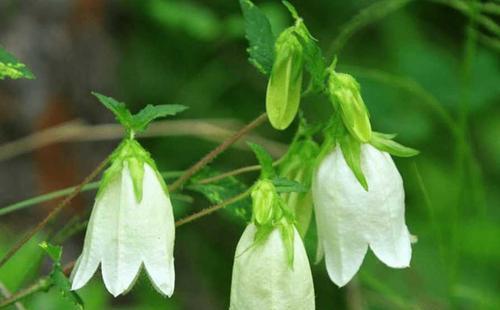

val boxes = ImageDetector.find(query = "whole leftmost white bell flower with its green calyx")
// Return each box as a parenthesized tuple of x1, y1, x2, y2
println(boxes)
(71, 139, 175, 297)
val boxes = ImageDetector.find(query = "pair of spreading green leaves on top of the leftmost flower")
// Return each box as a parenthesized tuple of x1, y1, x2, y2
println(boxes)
(92, 92, 188, 135)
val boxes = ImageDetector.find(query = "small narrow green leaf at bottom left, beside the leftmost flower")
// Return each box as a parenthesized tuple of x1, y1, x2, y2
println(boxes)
(39, 241, 84, 309)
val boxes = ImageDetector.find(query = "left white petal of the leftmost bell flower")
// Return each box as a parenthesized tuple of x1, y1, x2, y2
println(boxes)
(71, 167, 122, 290)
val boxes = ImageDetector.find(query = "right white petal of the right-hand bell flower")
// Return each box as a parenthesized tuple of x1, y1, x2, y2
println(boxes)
(361, 144, 411, 268)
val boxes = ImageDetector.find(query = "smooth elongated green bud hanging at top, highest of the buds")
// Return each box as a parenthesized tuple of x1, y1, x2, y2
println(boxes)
(266, 27, 304, 130)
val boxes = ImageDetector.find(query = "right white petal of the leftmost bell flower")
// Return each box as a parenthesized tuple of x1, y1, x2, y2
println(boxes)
(138, 164, 175, 297)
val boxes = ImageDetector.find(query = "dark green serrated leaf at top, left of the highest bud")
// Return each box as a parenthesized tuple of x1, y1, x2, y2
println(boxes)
(240, 0, 275, 74)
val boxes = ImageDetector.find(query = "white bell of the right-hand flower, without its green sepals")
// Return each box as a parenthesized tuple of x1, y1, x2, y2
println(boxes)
(313, 144, 411, 286)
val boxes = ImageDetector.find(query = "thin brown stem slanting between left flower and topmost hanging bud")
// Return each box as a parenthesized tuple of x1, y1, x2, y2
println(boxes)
(170, 113, 267, 192)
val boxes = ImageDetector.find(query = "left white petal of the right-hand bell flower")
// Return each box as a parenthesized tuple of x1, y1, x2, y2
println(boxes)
(313, 149, 368, 286)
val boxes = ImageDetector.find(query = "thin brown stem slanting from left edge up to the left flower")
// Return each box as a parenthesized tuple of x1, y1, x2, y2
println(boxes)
(0, 157, 109, 268)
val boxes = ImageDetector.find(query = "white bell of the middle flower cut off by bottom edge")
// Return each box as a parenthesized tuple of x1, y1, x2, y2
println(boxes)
(229, 224, 315, 310)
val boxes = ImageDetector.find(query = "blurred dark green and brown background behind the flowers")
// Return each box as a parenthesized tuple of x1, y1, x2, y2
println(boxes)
(0, 0, 500, 310)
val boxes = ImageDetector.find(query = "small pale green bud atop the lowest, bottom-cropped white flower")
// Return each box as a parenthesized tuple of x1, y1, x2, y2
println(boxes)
(252, 179, 279, 225)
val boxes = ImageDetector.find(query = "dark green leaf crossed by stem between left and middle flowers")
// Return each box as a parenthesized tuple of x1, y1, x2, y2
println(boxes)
(187, 167, 251, 222)
